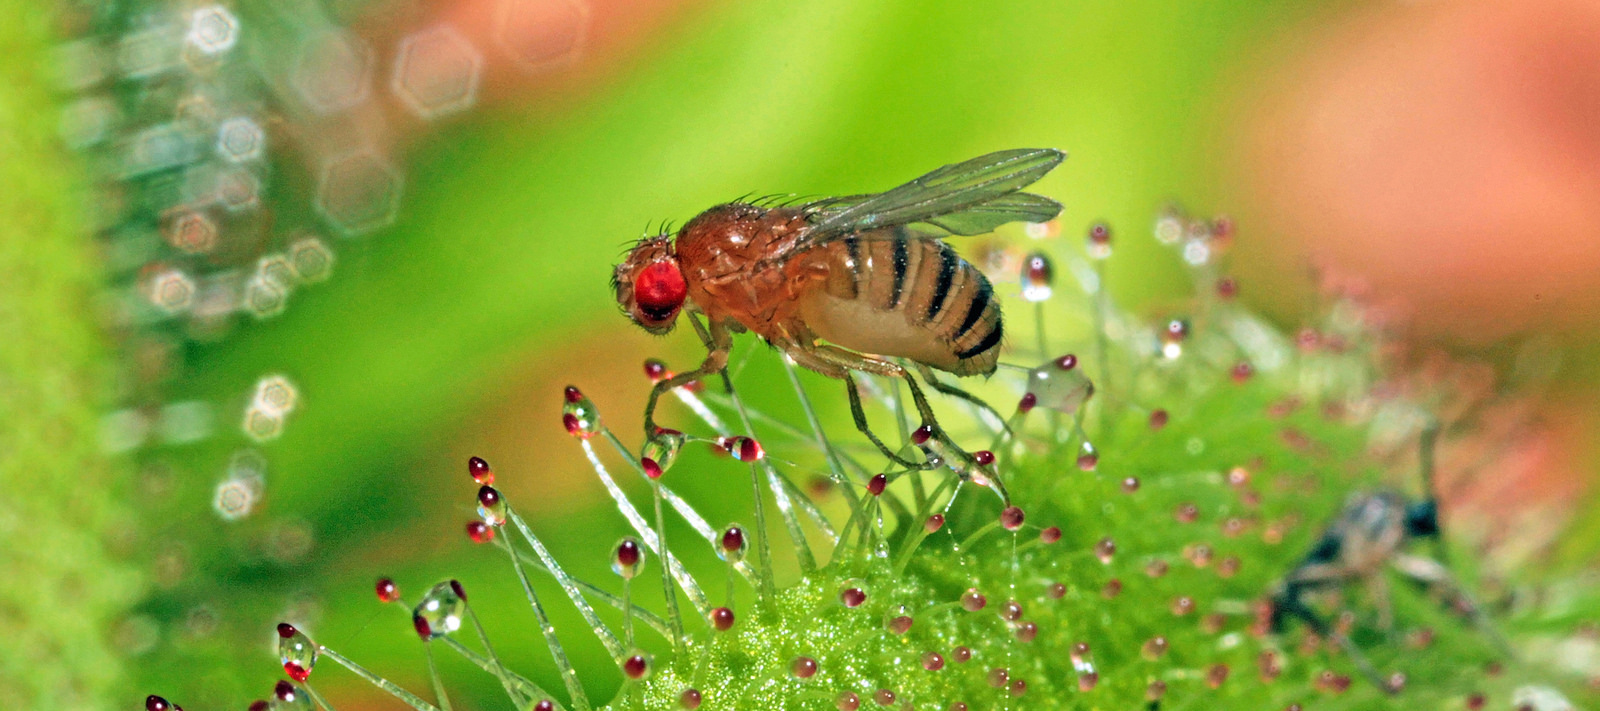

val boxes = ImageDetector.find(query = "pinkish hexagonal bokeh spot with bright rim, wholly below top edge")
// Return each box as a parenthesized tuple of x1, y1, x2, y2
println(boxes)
(390, 26, 483, 119)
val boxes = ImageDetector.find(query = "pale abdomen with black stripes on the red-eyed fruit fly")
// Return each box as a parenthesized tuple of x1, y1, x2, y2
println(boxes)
(802, 227, 1005, 375)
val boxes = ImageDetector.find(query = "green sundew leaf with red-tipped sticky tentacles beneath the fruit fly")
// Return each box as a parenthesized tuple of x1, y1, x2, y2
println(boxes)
(147, 211, 1595, 711)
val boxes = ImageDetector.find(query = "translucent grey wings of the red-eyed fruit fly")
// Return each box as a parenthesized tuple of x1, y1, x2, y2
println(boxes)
(795, 149, 1066, 247)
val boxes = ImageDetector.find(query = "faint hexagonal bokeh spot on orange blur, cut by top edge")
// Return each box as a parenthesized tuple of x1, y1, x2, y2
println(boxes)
(494, 0, 590, 72)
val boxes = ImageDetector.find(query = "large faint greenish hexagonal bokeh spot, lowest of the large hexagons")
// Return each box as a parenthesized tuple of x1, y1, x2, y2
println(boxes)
(315, 151, 400, 235)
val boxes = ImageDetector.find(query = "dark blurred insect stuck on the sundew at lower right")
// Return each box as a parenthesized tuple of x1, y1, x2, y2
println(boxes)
(1270, 424, 1510, 692)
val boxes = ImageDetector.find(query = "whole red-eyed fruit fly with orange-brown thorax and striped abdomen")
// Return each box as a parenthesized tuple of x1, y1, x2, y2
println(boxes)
(611, 149, 1066, 496)
